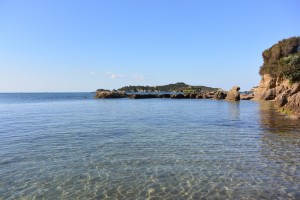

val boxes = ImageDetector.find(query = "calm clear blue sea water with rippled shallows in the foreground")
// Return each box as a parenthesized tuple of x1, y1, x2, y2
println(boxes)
(0, 93, 300, 199)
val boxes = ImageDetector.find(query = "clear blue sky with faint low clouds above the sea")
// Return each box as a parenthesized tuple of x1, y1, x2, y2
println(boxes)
(0, 0, 300, 92)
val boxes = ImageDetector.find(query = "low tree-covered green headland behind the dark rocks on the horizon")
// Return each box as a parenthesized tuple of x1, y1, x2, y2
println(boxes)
(118, 82, 219, 92)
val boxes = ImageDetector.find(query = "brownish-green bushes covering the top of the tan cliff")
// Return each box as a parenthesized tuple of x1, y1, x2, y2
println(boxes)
(259, 37, 300, 83)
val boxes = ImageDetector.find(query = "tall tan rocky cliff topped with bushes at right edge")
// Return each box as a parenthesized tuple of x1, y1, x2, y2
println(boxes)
(254, 37, 300, 119)
